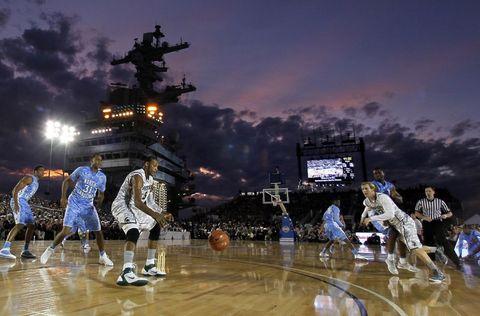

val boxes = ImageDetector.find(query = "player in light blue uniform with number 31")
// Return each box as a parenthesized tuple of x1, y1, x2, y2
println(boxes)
(40, 154, 113, 266)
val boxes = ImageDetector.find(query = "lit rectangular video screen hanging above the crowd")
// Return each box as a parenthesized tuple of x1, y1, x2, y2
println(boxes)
(307, 157, 355, 182)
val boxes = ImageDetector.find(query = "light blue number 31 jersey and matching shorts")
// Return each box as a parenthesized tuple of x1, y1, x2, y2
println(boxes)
(63, 166, 107, 231)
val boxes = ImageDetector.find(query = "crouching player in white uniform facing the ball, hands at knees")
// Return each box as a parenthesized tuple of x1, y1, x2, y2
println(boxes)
(112, 157, 172, 286)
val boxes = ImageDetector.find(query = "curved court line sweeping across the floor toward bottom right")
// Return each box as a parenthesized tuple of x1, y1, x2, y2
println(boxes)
(192, 256, 408, 316)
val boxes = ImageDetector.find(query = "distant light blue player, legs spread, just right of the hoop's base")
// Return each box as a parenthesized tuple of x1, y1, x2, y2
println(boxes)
(320, 199, 366, 260)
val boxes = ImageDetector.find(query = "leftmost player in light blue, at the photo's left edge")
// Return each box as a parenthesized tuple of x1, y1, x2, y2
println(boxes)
(0, 166, 45, 259)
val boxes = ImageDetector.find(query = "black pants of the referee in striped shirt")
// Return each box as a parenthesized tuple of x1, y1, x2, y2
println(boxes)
(423, 220, 460, 266)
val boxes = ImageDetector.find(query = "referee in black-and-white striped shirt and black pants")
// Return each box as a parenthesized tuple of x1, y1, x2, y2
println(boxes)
(415, 186, 460, 267)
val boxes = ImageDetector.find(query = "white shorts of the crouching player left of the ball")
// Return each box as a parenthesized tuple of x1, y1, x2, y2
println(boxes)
(112, 202, 157, 234)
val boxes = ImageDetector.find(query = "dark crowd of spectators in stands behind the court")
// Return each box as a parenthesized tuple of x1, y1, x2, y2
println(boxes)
(0, 187, 472, 244)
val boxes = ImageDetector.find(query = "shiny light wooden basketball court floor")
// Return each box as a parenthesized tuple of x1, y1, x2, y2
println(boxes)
(0, 240, 480, 316)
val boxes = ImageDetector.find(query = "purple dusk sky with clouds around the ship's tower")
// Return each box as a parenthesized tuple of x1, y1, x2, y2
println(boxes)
(0, 0, 480, 214)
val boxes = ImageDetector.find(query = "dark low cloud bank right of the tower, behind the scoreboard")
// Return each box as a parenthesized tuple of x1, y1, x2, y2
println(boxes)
(164, 101, 480, 216)
